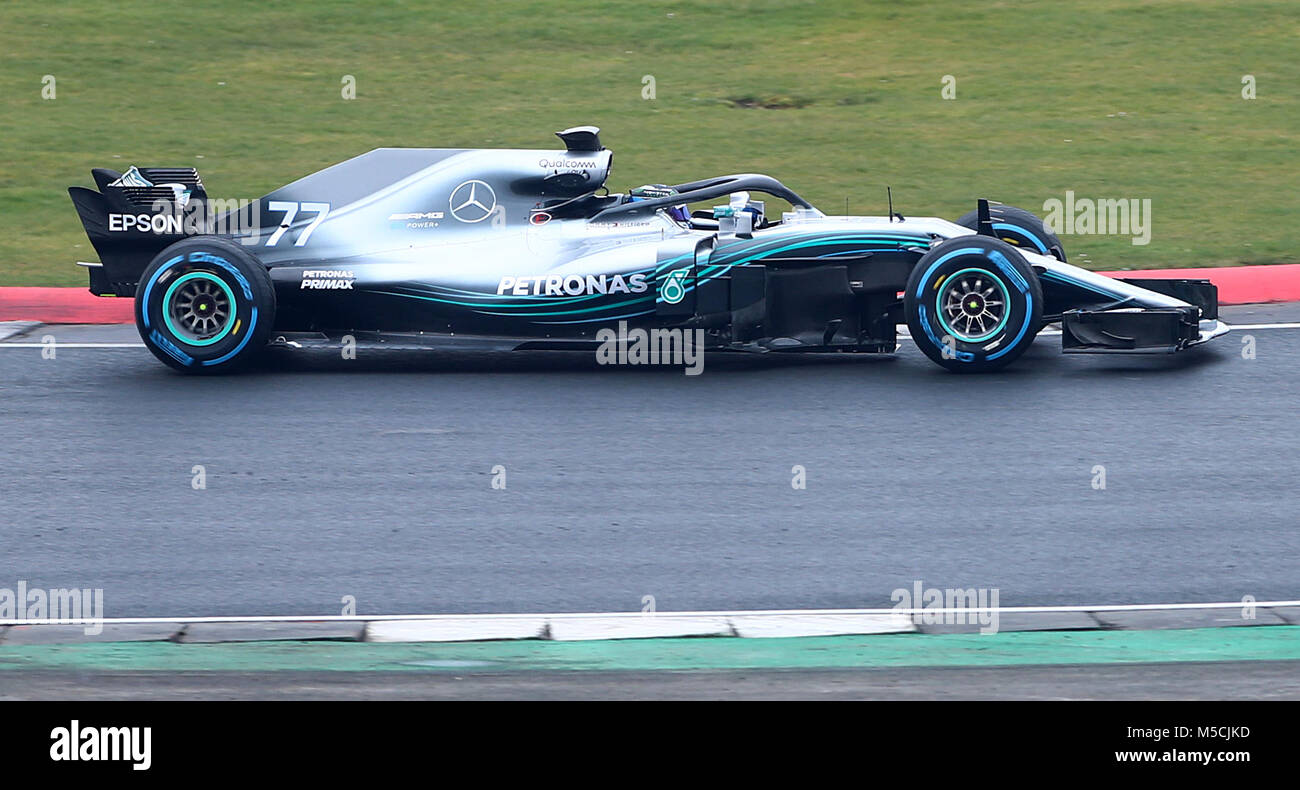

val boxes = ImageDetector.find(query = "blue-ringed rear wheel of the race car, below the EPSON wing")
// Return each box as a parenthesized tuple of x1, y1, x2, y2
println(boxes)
(135, 236, 276, 373)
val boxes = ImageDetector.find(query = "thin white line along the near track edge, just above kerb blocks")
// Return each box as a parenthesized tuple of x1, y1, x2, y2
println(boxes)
(0, 600, 1300, 626)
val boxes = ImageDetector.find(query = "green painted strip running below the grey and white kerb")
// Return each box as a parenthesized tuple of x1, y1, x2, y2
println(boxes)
(0, 626, 1300, 672)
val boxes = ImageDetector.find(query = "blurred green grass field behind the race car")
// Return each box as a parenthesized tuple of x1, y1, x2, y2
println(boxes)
(0, 0, 1300, 285)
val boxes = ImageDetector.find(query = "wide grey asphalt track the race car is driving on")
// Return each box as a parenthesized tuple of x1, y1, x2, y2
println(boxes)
(0, 305, 1300, 617)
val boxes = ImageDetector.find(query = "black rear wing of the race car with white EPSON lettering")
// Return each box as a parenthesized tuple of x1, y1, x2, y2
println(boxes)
(68, 166, 208, 296)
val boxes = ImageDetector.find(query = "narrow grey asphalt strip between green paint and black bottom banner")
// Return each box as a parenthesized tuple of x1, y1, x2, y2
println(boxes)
(0, 661, 1300, 700)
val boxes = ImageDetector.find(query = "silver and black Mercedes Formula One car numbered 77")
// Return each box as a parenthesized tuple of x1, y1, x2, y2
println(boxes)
(69, 126, 1229, 373)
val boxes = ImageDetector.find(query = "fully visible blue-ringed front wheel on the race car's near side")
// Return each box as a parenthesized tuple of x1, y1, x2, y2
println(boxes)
(904, 236, 1043, 373)
